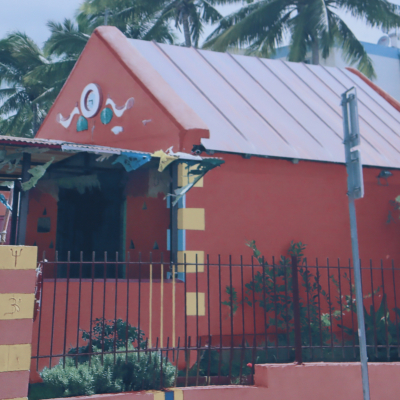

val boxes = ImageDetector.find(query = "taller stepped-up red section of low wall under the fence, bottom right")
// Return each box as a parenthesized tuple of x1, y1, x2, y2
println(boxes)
(255, 363, 400, 400)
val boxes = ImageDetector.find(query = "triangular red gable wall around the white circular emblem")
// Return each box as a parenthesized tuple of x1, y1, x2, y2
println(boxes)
(37, 31, 179, 152)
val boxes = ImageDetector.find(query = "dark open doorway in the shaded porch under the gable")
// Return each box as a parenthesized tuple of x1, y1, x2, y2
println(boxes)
(56, 174, 123, 278)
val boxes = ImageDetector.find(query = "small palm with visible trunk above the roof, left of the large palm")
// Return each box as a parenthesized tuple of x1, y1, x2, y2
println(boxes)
(153, 0, 228, 47)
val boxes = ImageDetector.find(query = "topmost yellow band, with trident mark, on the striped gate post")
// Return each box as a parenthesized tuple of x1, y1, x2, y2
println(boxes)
(0, 246, 37, 269)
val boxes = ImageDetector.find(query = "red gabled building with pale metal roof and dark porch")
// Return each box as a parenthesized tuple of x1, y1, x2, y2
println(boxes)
(2, 27, 400, 380)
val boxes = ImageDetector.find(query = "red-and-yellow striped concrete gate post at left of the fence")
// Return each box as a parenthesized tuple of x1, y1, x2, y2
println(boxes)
(0, 246, 37, 400)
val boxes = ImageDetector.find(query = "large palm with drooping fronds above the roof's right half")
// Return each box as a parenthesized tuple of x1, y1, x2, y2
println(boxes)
(205, 0, 400, 78)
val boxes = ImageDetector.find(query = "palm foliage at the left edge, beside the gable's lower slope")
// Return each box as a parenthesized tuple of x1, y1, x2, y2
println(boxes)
(0, 32, 56, 137)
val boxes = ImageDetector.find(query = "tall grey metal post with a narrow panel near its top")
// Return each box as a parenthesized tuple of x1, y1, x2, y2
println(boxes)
(341, 87, 370, 400)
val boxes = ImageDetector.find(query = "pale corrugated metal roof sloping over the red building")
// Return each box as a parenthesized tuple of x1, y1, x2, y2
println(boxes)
(130, 39, 400, 168)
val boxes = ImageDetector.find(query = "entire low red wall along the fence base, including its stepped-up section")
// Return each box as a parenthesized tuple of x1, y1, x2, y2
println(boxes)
(36, 363, 400, 400)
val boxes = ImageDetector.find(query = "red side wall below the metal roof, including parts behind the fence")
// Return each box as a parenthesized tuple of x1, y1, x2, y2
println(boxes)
(182, 154, 400, 340)
